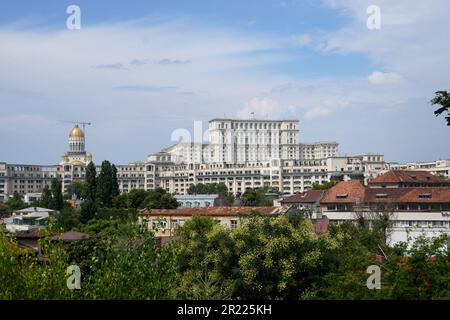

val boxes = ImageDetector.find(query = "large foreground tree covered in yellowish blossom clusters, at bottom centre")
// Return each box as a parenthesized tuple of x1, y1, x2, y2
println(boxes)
(231, 215, 337, 299)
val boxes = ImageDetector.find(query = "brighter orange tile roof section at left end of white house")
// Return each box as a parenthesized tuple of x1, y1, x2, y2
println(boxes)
(321, 180, 365, 203)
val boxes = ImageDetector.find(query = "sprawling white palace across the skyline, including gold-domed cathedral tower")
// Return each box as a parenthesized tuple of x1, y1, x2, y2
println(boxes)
(0, 119, 450, 201)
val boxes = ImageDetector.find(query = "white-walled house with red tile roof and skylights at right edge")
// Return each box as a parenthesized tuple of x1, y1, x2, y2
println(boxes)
(321, 181, 450, 243)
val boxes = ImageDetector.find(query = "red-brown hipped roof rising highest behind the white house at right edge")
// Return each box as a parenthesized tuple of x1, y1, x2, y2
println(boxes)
(369, 170, 449, 185)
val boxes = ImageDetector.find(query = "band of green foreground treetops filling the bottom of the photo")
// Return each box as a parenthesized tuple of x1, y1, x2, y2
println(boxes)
(0, 215, 450, 299)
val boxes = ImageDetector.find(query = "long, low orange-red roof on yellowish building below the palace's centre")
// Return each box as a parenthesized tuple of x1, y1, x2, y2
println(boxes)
(139, 207, 280, 217)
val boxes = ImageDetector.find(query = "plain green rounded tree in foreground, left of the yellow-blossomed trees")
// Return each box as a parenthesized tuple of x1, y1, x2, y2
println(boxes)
(82, 223, 178, 300)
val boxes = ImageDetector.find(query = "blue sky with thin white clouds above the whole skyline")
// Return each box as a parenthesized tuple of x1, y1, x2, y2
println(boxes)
(0, 0, 450, 164)
